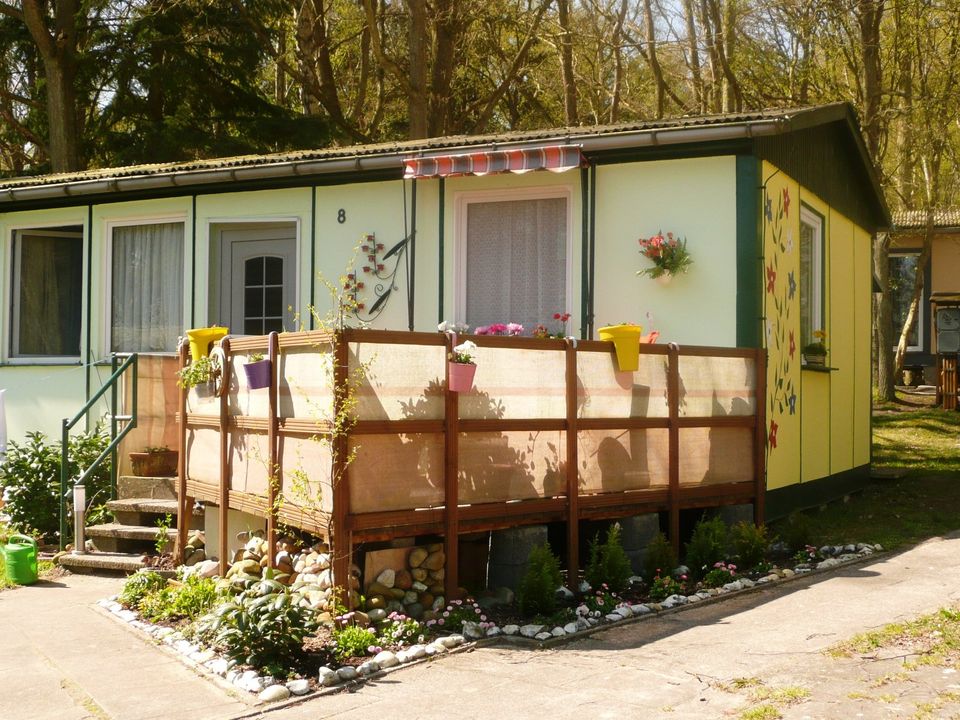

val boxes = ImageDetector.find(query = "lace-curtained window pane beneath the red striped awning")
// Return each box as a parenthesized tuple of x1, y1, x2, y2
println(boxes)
(464, 191, 569, 331)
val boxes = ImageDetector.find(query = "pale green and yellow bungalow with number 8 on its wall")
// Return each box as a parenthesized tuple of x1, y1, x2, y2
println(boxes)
(0, 104, 889, 515)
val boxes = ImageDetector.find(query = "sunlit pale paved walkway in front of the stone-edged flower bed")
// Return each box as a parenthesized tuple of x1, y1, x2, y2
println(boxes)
(0, 536, 960, 720)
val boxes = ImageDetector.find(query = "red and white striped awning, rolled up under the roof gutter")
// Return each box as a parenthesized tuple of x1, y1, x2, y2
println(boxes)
(403, 145, 583, 179)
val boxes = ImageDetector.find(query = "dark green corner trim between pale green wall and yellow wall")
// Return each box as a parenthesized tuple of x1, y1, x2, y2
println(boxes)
(737, 155, 763, 347)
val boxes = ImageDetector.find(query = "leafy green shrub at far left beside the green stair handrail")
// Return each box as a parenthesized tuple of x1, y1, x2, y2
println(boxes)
(0, 428, 110, 542)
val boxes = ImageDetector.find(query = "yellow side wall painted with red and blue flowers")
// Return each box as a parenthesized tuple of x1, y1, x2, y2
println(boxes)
(763, 163, 871, 489)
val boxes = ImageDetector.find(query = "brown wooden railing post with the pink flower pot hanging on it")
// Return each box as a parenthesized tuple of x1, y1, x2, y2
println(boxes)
(443, 333, 460, 602)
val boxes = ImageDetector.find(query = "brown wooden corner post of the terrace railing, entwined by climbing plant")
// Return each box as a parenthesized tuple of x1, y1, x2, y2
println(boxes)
(328, 330, 353, 609)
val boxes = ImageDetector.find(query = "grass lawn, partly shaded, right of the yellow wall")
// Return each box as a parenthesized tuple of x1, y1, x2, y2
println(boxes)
(773, 395, 960, 550)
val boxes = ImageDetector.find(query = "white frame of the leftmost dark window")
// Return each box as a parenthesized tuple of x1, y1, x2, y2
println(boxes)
(8, 226, 90, 365)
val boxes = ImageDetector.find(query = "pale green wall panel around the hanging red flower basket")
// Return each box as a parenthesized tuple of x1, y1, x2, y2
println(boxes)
(595, 156, 737, 346)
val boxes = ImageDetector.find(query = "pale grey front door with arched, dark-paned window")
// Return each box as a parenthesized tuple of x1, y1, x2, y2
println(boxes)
(219, 223, 297, 335)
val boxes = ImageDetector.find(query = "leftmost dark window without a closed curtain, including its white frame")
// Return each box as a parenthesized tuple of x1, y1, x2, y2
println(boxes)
(10, 226, 83, 358)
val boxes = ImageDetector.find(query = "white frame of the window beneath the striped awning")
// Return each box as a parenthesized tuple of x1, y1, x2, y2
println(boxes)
(454, 185, 574, 330)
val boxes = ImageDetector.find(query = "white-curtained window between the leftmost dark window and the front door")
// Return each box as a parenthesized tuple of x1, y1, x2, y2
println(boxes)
(110, 222, 183, 352)
